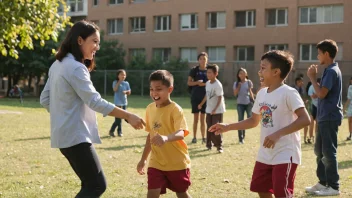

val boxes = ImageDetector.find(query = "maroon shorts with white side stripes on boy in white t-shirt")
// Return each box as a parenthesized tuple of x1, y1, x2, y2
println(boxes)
(250, 162, 298, 197)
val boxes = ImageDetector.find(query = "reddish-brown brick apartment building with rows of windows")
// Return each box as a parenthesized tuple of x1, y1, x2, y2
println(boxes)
(63, 0, 352, 95)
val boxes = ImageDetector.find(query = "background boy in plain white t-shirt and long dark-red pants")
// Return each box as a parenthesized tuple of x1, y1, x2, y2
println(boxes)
(198, 65, 226, 153)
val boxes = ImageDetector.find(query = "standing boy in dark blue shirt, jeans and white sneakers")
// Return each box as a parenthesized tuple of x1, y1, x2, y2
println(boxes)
(306, 39, 343, 196)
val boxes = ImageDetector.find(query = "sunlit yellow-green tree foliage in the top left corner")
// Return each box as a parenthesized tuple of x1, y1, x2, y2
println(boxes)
(0, 0, 71, 59)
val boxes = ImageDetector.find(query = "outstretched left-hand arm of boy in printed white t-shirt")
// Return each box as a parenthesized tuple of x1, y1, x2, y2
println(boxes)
(209, 113, 261, 135)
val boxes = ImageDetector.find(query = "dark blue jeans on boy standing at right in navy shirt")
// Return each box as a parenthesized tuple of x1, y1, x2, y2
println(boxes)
(314, 121, 341, 190)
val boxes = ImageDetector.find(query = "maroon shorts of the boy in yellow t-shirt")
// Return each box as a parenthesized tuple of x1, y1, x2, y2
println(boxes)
(148, 168, 191, 194)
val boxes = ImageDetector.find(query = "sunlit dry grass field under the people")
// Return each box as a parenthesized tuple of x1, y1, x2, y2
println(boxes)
(0, 97, 352, 198)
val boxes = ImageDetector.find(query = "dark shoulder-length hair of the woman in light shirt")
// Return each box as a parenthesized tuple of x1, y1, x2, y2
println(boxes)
(55, 20, 99, 71)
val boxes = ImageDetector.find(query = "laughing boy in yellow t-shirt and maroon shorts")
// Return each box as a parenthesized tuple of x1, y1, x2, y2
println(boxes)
(137, 70, 191, 198)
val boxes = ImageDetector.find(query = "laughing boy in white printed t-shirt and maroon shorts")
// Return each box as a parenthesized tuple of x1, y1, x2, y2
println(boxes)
(210, 50, 310, 198)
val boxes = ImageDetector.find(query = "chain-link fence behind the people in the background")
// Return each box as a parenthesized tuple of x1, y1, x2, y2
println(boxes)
(91, 61, 352, 98)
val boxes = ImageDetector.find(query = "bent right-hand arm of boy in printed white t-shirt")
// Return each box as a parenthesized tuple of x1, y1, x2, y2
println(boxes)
(263, 107, 310, 148)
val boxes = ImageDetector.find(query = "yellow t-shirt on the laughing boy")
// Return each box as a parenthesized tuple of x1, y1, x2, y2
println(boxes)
(146, 102, 191, 171)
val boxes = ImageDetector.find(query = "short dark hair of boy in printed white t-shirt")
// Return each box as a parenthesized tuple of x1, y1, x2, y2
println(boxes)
(260, 50, 294, 79)
